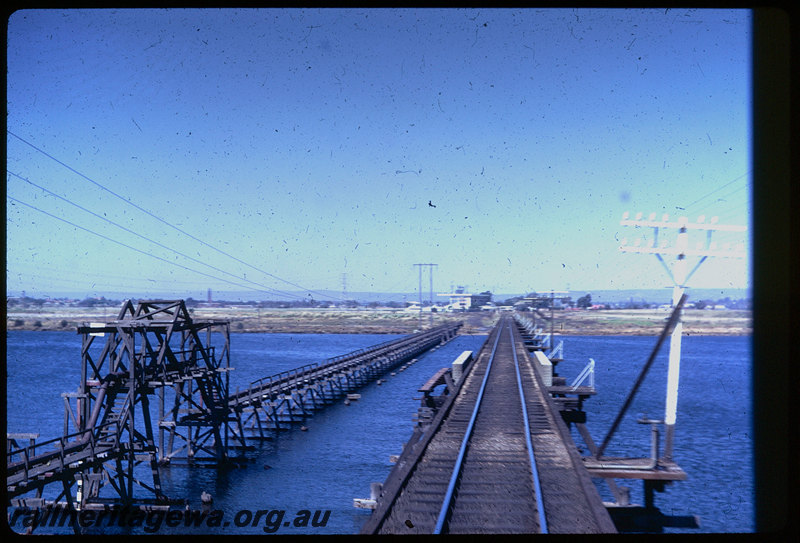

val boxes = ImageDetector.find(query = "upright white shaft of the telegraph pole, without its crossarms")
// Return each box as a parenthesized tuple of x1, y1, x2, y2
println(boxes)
(664, 217, 689, 460)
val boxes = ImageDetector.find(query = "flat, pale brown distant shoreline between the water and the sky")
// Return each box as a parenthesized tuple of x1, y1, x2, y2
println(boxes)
(6, 307, 753, 336)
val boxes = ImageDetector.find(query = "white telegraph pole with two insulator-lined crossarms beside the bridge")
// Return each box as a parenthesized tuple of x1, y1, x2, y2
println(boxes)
(619, 211, 747, 460)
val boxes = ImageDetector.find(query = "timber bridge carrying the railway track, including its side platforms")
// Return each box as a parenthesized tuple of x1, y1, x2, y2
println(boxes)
(354, 314, 697, 534)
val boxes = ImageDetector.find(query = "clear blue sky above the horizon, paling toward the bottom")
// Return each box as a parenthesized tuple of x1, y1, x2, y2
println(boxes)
(6, 9, 752, 298)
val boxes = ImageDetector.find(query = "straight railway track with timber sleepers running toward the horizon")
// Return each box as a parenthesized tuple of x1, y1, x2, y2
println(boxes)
(362, 317, 614, 534)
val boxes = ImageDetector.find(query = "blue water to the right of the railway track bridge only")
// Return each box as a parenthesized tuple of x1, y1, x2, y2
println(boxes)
(559, 336, 755, 533)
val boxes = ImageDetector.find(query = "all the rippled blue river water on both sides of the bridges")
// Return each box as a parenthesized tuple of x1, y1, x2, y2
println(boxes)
(6, 331, 754, 535)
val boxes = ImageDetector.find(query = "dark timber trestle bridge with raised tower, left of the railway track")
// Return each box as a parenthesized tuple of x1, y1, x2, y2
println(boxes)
(6, 300, 461, 511)
